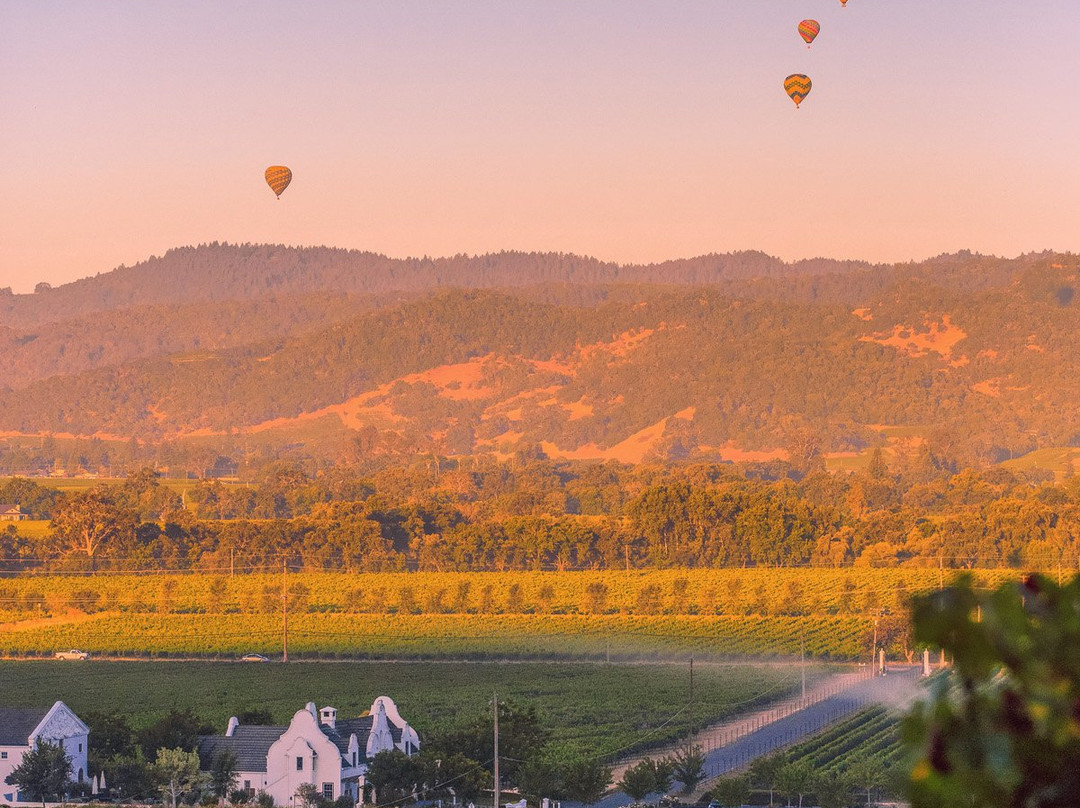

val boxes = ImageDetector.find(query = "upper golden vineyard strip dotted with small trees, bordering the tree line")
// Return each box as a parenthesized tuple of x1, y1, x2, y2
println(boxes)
(0, 567, 1022, 623)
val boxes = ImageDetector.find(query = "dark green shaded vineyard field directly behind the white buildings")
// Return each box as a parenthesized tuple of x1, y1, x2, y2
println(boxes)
(0, 660, 829, 754)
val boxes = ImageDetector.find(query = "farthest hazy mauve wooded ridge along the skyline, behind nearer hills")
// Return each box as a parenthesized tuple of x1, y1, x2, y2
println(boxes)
(0, 243, 869, 328)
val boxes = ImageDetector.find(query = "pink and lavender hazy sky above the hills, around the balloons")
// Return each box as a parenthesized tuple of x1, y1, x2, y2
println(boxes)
(0, 0, 1080, 292)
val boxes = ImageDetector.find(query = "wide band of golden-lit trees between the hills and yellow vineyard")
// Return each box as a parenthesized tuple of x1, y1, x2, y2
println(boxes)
(0, 456, 1080, 573)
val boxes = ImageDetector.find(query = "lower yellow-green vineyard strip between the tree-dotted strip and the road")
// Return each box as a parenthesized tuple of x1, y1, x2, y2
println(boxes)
(0, 614, 873, 661)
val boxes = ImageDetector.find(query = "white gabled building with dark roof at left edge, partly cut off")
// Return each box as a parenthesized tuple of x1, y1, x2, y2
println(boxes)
(0, 701, 90, 803)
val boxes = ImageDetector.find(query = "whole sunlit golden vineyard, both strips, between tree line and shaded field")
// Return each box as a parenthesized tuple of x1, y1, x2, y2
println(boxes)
(0, 568, 1017, 661)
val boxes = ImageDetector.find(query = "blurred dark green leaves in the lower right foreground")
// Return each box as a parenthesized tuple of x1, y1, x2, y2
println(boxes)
(908, 576, 1080, 808)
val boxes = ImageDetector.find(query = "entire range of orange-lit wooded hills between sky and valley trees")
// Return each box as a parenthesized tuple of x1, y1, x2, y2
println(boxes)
(0, 245, 1080, 466)
